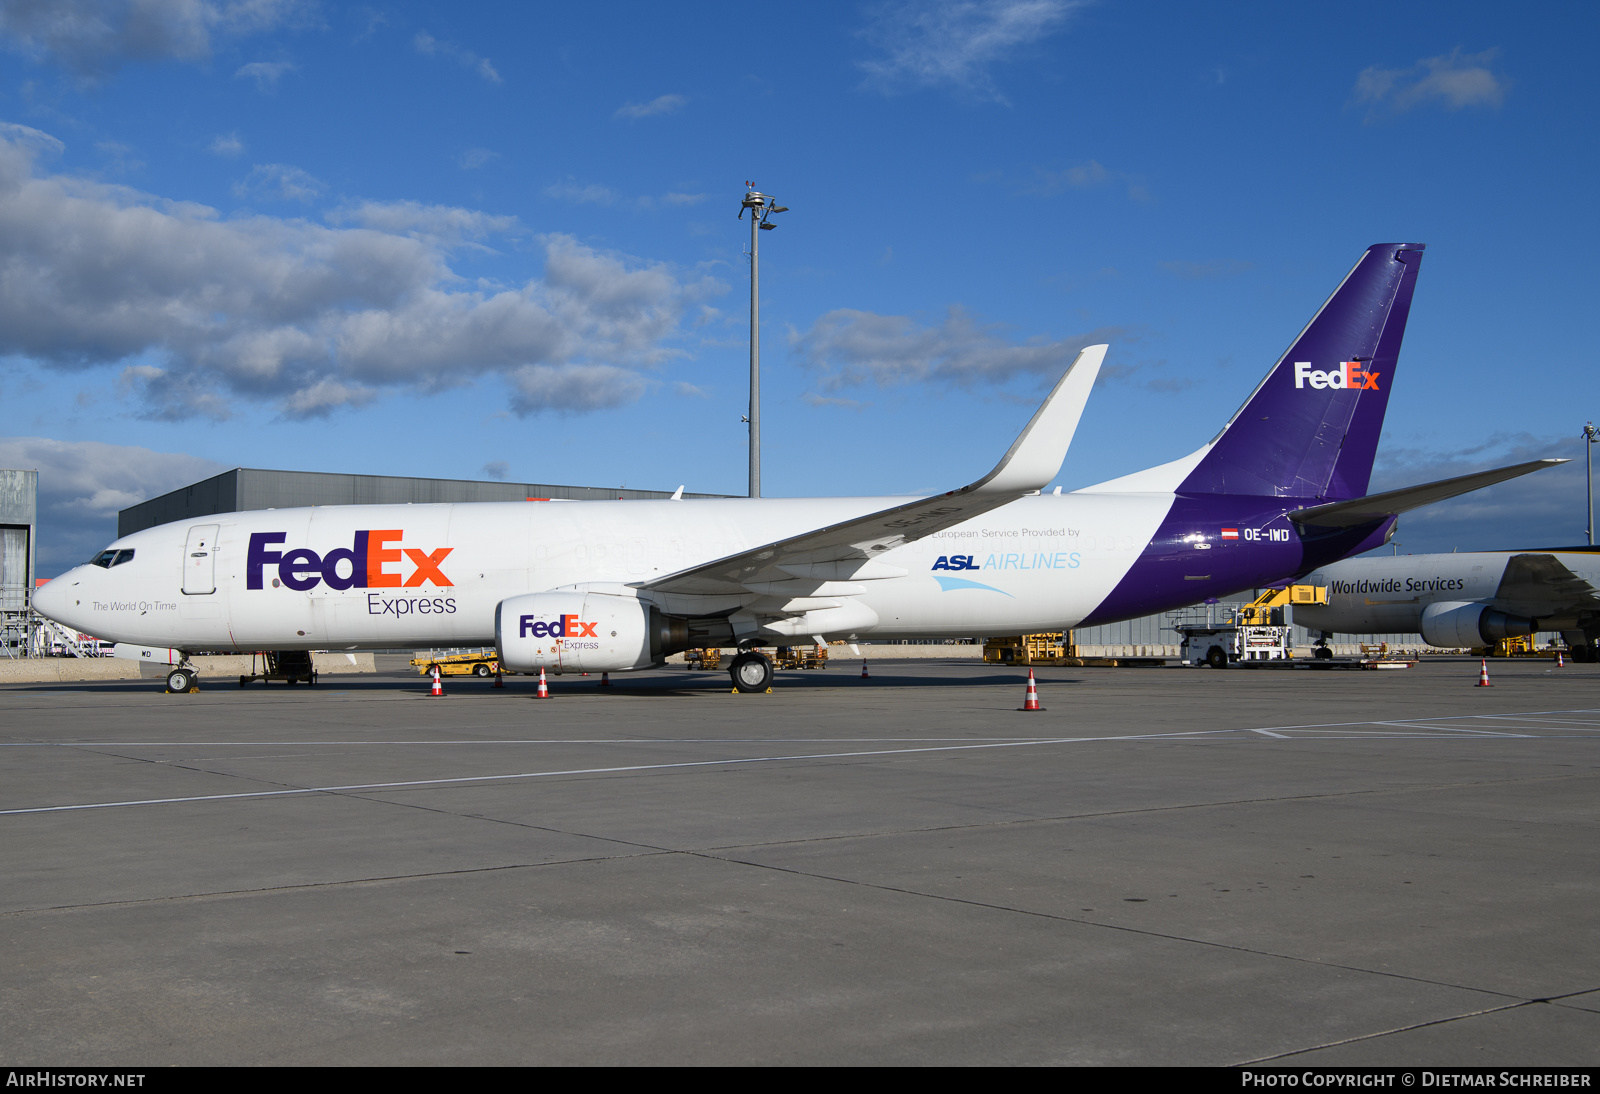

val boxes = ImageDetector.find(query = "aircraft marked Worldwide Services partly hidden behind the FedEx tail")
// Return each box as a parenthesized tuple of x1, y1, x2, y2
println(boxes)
(1294, 547, 1600, 661)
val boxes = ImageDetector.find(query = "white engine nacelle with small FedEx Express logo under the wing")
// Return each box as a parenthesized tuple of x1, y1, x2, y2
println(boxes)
(494, 590, 688, 672)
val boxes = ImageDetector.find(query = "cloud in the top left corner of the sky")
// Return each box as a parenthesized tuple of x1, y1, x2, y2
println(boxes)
(0, 0, 315, 78)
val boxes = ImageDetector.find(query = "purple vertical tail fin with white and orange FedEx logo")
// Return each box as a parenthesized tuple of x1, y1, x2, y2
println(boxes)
(1178, 243, 1422, 499)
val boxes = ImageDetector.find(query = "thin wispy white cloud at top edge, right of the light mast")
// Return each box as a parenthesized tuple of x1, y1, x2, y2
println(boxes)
(861, 0, 1085, 102)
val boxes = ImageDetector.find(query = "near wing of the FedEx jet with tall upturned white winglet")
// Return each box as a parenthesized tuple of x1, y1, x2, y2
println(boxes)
(638, 345, 1107, 595)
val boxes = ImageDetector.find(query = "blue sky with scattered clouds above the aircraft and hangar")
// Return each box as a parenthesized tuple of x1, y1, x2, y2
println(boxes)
(0, 0, 1600, 574)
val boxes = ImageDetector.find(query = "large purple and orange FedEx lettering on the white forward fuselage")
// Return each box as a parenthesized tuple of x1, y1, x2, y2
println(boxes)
(245, 528, 454, 592)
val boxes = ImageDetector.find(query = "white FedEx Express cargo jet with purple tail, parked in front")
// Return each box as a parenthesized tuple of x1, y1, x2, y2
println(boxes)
(34, 243, 1562, 691)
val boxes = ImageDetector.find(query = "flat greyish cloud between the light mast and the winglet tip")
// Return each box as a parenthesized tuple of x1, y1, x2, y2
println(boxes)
(790, 305, 1122, 390)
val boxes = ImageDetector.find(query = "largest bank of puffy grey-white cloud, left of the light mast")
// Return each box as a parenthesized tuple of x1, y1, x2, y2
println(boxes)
(0, 130, 726, 419)
